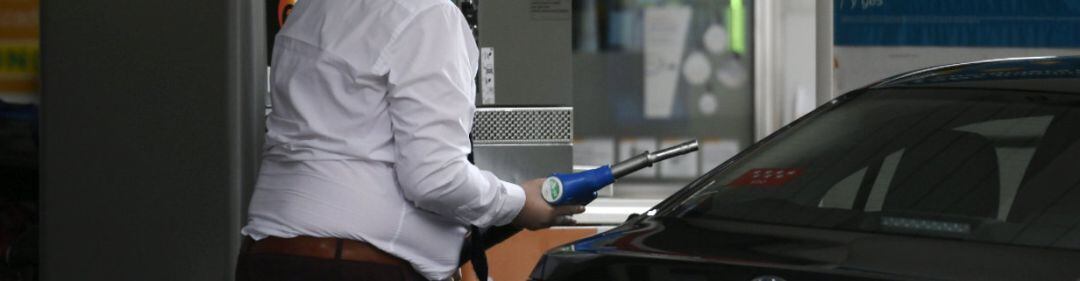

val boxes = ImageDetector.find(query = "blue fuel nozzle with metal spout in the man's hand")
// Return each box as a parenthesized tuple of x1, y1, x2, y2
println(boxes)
(540, 139, 698, 205)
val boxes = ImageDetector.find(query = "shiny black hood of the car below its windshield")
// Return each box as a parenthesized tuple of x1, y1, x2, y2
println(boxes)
(530, 217, 1080, 281)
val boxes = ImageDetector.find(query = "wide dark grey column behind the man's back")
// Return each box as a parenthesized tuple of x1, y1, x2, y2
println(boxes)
(41, 0, 266, 281)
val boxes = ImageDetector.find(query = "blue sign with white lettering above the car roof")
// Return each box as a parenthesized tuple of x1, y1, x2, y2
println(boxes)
(834, 0, 1080, 48)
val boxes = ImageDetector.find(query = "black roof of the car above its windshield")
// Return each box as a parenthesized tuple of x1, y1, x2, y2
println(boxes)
(866, 56, 1080, 94)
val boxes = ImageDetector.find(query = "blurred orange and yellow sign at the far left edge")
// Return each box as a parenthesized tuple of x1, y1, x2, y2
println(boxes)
(0, 0, 41, 94)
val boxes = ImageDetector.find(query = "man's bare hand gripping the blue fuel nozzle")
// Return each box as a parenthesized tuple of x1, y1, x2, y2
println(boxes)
(512, 178, 585, 230)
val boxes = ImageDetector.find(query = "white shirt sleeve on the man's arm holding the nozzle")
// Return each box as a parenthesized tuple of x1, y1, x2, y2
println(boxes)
(380, 4, 525, 227)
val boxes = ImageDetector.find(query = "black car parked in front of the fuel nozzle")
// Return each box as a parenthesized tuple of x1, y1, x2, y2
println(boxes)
(530, 57, 1080, 281)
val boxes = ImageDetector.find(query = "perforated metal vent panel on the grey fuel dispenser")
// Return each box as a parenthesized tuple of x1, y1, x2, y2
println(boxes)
(472, 107, 573, 145)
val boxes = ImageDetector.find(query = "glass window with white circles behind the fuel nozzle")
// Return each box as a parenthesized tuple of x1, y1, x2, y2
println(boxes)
(572, 0, 754, 198)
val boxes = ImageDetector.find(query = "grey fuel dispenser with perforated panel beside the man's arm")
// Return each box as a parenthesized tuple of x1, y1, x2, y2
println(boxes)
(458, 0, 573, 188)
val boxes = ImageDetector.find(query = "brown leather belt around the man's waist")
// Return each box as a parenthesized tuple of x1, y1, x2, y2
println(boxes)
(245, 237, 413, 269)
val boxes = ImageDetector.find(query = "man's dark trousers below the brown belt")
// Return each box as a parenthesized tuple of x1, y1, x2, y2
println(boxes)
(237, 253, 427, 281)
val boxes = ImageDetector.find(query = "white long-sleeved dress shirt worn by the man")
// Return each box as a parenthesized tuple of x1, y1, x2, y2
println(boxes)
(242, 0, 525, 279)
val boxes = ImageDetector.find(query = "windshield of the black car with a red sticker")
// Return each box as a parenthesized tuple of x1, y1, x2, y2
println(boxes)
(660, 89, 1080, 250)
